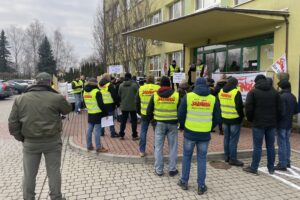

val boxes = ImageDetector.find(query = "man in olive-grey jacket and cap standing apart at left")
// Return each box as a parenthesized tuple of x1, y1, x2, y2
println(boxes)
(9, 72, 72, 200)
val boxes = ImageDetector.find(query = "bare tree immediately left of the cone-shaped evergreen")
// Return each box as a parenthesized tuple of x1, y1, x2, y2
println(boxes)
(25, 20, 45, 74)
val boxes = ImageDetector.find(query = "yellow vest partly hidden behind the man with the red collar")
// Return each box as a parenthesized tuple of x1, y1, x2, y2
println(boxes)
(139, 84, 159, 115)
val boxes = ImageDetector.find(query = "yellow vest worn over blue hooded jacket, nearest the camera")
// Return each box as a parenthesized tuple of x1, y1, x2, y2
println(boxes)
(184, 92, 216, 132)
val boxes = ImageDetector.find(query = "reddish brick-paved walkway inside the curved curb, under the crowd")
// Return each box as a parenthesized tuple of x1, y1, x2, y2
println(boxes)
(64, 112, 300, 156)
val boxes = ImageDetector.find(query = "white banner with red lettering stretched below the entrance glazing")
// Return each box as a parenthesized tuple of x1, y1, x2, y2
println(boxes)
(212, 72, 267, 102)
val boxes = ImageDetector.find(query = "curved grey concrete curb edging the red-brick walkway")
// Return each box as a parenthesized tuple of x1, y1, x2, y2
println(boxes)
(69, 136, 272, 164)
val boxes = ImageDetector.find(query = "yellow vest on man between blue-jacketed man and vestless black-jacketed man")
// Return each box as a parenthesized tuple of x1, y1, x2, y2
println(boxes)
(219, 89, 239, 119)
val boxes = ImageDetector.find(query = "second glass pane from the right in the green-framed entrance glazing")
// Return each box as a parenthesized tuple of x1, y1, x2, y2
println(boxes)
(243, 47, 258, 71)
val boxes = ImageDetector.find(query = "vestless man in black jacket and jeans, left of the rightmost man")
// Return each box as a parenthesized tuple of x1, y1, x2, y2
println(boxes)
(243, 74, 280, 174)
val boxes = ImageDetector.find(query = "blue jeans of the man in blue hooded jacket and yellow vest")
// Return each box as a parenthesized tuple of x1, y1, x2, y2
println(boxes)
(180, 138, 209, 187)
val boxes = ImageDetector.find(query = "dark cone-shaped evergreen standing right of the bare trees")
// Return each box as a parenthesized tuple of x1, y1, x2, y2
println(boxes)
(38, 37, 56, 74)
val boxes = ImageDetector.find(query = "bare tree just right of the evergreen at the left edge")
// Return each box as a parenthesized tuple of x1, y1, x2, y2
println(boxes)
(7, 25, 24, 72)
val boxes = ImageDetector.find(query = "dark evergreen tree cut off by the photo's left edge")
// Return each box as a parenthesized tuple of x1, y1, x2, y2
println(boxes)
(0, 30, 10, 72)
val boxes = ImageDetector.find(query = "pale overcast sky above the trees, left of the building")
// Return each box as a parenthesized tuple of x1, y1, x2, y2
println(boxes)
(0, 0, 102, 58)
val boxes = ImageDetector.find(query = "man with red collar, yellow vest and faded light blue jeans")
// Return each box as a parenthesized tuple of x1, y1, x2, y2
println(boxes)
(147, 76, 180, 176)
